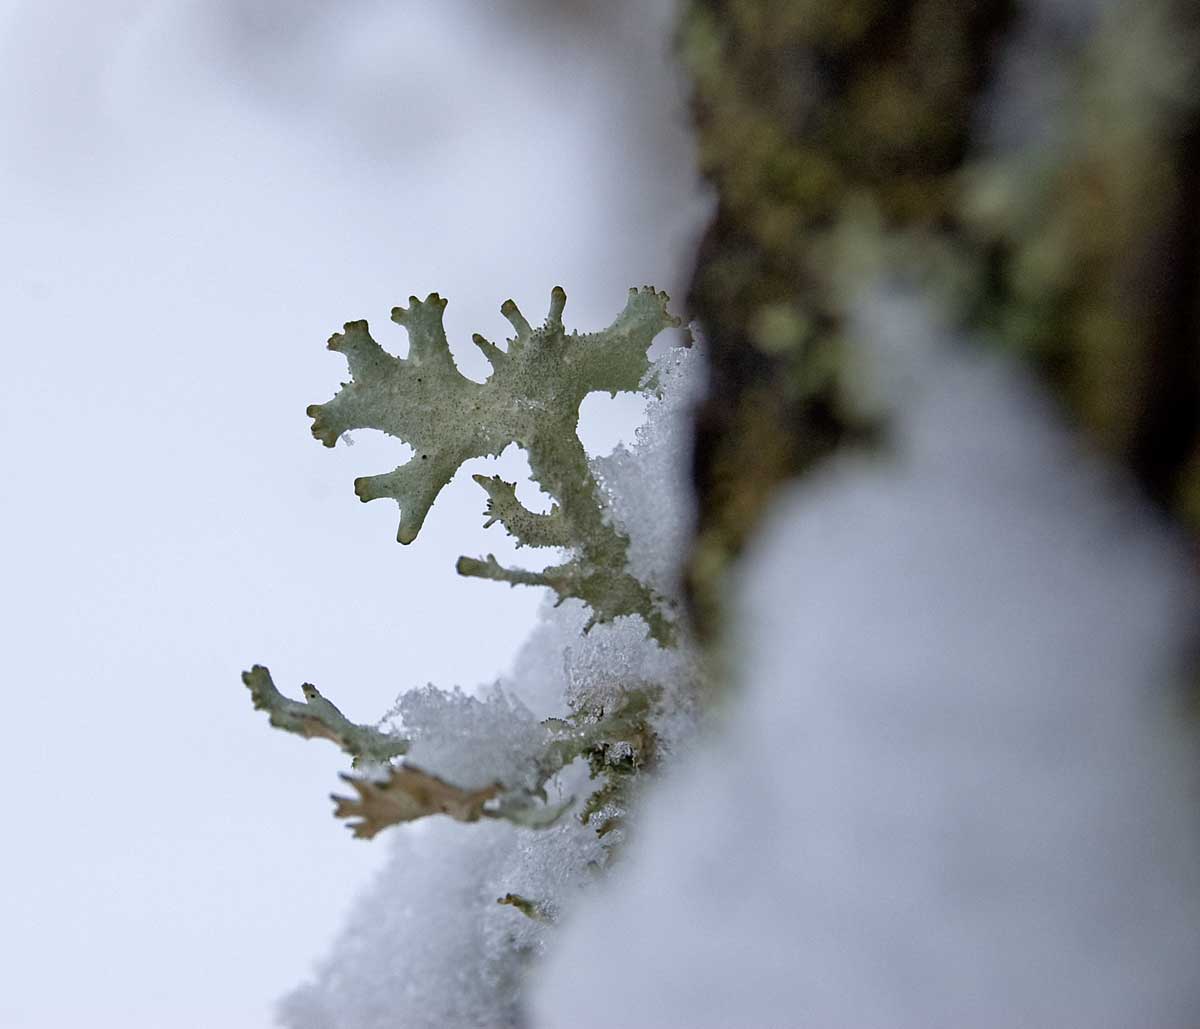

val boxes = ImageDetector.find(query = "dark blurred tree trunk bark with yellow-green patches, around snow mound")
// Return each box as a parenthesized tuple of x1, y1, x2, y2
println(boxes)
(679, 0, 1200, 634)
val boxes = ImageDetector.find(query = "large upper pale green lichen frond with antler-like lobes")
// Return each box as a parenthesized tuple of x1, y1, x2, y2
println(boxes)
(308, 287, 679, 644)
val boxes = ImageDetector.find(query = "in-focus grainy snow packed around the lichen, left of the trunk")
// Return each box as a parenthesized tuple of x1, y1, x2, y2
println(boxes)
(278, 349, 701, 1029)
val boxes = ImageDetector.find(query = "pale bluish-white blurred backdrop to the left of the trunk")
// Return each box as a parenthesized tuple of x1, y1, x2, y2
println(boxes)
(0, 0, 706, 1029)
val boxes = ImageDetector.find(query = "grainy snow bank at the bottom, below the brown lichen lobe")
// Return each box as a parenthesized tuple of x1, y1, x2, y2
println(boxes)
(280, 819, 585, 1029)
